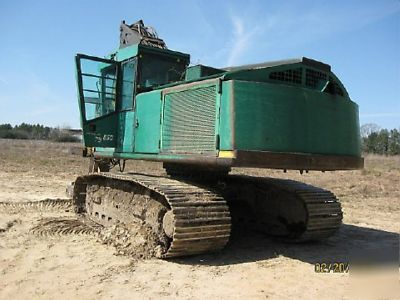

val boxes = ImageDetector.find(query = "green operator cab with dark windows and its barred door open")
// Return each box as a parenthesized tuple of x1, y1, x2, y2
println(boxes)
(76, 44, 190, 147)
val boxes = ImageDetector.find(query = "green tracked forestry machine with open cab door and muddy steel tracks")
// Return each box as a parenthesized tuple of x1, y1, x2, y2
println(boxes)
(73, 21, 363, 258)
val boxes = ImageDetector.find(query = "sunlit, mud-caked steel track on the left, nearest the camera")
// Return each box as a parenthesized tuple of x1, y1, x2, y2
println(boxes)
(74, 173, 231, 258)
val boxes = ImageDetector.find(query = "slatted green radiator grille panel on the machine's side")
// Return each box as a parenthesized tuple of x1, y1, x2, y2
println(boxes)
(161, 85, 216, 153)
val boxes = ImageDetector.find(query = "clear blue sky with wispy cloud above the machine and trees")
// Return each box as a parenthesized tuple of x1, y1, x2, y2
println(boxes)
(0, 0, 400, 129)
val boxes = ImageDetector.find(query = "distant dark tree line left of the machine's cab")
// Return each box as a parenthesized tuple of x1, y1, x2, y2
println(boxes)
(0, 123, 80, 142)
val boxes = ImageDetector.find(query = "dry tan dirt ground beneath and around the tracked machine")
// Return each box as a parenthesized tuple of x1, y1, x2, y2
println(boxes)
(0, 139, 400, 299)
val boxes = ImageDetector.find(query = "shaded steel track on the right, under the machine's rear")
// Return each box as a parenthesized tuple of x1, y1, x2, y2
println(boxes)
(225, 175, 343, 242)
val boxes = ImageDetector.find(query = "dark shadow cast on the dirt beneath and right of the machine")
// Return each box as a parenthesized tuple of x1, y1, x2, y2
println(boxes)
(175, 224, 399, 266)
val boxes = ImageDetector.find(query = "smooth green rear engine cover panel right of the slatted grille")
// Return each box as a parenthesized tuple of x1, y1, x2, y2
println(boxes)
(221, 80, 361, 156)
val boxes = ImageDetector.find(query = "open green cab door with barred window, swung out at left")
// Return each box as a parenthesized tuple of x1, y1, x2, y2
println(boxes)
(75, 54, 120, 148)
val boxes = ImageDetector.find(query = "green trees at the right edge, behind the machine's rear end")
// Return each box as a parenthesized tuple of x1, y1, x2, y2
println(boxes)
(362, 129, 400, 155)
